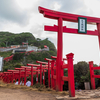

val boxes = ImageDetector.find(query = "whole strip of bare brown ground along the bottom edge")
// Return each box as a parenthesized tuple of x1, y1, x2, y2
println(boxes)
(0, 87, 100, 100)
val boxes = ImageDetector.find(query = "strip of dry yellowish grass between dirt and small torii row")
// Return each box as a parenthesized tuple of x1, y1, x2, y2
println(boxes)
(0, 81, 69, 96)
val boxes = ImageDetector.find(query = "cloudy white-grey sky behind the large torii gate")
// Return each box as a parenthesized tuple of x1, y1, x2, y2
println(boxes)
(0, 0, 100, 65)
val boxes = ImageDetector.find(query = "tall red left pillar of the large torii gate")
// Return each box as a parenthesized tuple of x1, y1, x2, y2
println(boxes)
(39, 7, 63, 91)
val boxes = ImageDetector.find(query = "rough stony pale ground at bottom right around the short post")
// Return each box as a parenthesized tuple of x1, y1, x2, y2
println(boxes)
(58, 89, 100, 100)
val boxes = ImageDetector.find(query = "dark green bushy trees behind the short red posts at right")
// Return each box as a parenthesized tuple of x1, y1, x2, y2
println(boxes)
(74, 61, 100, 89)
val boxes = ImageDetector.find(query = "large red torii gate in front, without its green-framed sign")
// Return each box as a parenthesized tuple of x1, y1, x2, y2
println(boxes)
(39, 7, 100, 90)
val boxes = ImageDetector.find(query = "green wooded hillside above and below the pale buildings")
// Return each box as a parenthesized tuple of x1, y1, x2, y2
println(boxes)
(0, 32, 56, 71)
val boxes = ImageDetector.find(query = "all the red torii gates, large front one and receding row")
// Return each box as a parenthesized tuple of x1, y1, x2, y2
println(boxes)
(0, 7, 100, 97)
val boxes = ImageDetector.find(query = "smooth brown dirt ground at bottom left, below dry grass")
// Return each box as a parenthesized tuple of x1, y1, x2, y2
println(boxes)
(0, 88, 55, 100)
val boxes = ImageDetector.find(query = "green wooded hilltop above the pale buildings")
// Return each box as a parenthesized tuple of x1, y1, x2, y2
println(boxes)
(0, 32, 56, 53)
